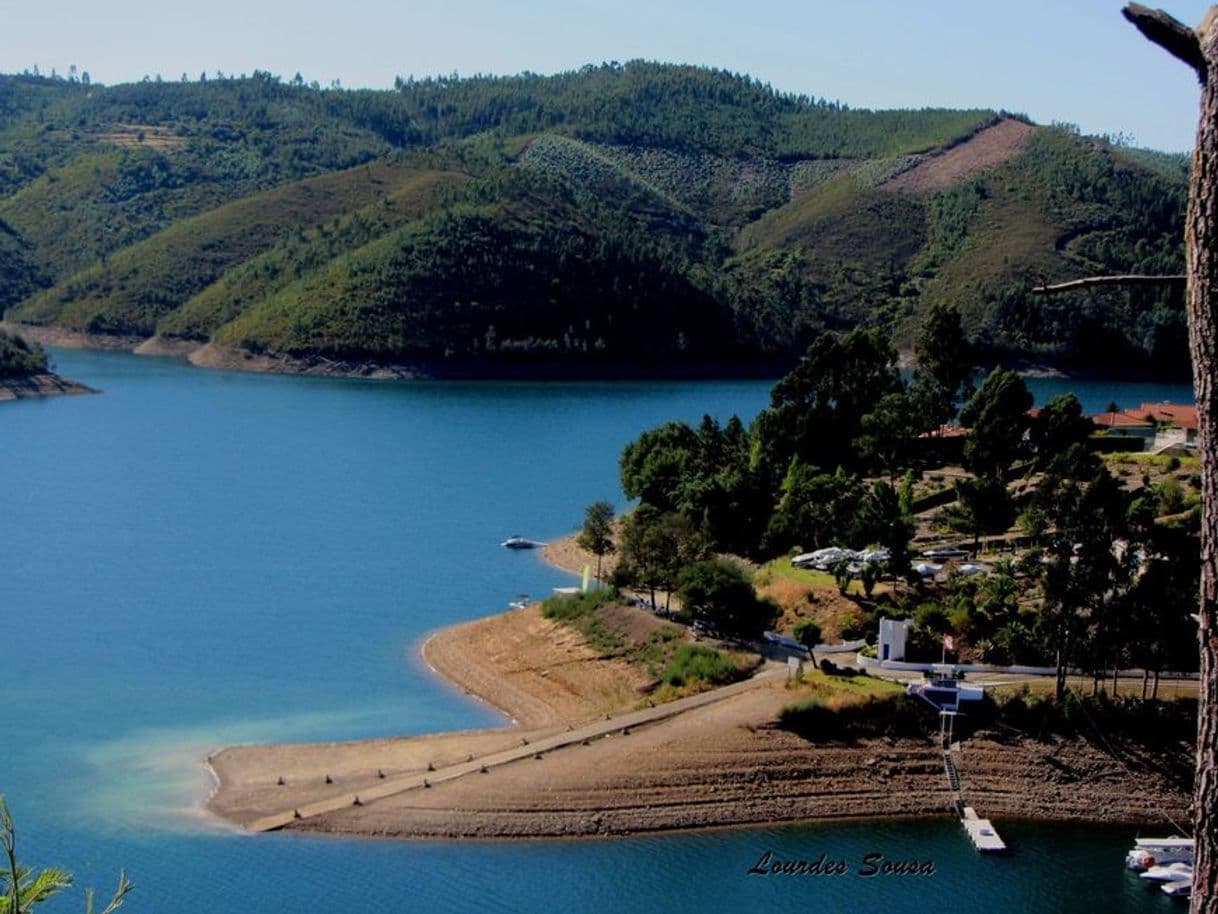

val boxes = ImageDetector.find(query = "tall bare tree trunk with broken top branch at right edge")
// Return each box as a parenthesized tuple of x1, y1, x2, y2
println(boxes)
(1123, 4, 1218, 914)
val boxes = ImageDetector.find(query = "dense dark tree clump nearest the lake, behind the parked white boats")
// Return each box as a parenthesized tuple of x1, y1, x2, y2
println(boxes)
(621, 306, 973, 572)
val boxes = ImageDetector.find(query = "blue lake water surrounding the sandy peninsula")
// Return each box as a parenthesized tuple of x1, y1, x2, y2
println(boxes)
(0, 351, 1190, 914)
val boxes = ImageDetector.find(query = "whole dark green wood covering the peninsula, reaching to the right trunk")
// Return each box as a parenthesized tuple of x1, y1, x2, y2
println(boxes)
(618, 307, 1199, 687)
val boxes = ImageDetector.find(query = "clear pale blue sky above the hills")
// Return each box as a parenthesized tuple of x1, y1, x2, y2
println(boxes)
(0, 0, 1208, 150)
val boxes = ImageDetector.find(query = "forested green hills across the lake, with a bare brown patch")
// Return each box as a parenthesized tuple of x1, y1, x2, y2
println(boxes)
(0, 62, 1188, 375)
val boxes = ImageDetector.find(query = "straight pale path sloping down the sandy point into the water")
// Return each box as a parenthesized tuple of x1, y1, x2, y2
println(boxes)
(245, 664, 787, 831)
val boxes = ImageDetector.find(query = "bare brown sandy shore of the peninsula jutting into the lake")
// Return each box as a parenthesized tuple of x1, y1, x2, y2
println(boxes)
(208, 589, 1189, 838)
